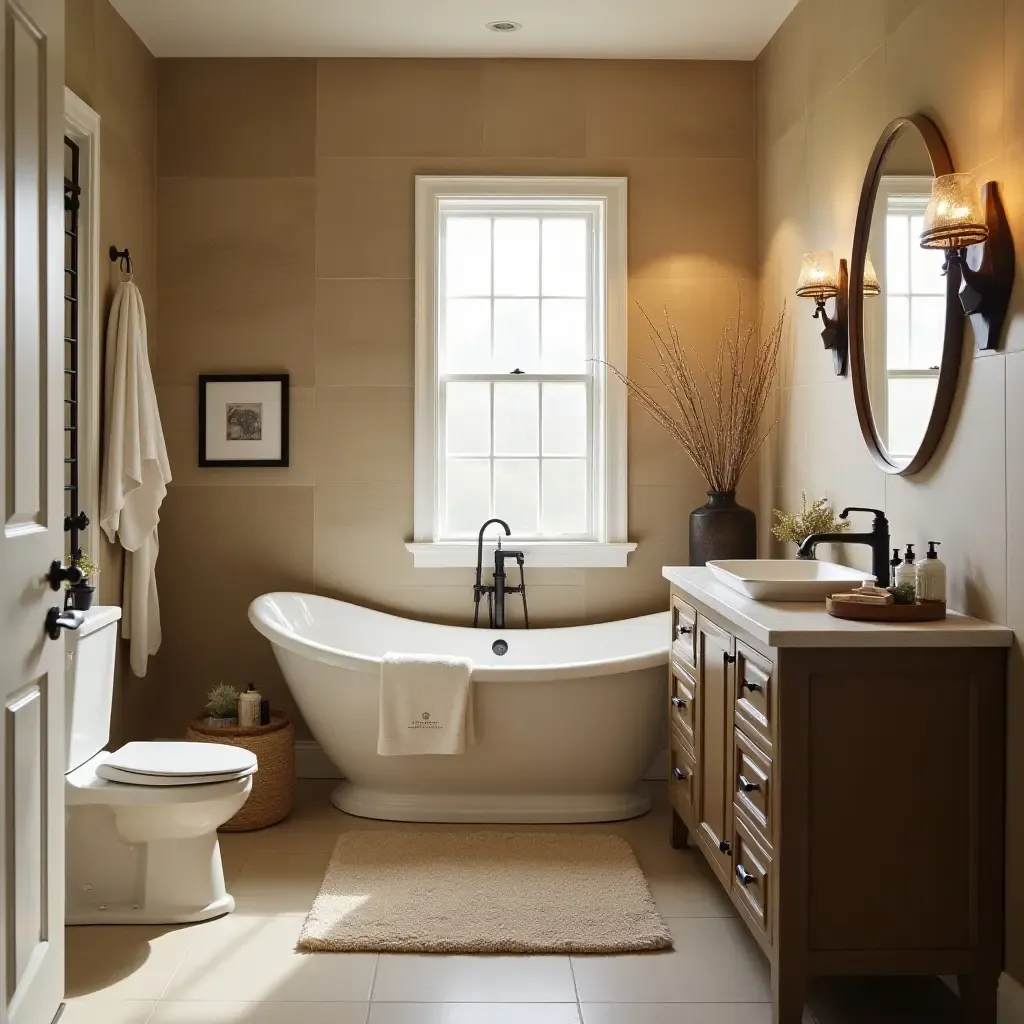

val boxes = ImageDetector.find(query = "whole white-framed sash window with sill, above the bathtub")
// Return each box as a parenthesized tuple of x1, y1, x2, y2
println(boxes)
(409, 177, 635, 565)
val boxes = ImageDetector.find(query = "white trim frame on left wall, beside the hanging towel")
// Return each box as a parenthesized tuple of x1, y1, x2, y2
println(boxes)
(61, 86, 103, 562)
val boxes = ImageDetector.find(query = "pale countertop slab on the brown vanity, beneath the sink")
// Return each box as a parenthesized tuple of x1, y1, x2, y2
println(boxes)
(662, 565, 1014, 647)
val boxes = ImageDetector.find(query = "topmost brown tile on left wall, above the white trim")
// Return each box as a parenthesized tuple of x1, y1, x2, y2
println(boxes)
(93, 0, 157, 158)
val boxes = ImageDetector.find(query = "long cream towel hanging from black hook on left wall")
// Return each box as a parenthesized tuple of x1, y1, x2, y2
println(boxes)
(99, 281, 171, 676)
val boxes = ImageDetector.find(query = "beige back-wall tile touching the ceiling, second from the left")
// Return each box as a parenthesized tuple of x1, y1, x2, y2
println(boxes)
(316, 57, 483, 157)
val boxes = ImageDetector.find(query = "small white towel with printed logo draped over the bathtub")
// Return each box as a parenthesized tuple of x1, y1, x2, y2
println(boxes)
(377, 652, 474, 755)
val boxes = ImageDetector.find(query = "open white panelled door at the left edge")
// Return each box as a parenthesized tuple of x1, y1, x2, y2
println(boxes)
(0, 0, 65, 1024)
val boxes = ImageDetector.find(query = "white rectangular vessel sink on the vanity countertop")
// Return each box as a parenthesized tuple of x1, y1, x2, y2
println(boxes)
(708, 558, 874, 601)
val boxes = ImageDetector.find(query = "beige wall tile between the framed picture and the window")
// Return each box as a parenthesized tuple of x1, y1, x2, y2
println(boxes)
(316, 387, 413, 485)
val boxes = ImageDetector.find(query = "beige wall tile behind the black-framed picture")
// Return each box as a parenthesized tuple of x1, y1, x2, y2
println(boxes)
(157, 384, 314, 487)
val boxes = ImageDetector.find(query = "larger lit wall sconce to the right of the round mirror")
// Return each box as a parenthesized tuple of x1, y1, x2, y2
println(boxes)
(921, 174, 1015, 349)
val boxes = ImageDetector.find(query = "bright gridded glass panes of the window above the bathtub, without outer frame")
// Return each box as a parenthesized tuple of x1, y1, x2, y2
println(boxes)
(437, 209, 596, 540)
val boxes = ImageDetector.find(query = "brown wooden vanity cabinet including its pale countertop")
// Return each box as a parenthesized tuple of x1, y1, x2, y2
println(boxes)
(665, 567, 1012, 1024)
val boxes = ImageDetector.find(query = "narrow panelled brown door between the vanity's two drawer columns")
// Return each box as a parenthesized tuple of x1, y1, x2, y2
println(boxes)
(696, 616, 735, 885)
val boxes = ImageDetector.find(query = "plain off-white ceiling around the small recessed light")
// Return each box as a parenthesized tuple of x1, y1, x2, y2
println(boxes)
(113, 0, 796, 60)
